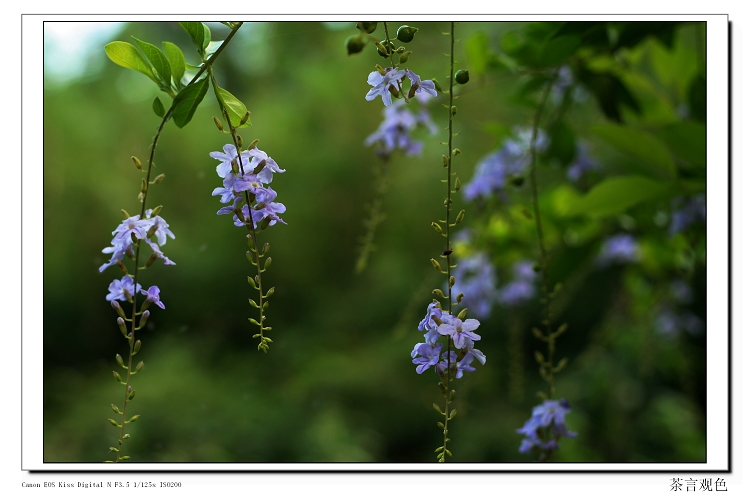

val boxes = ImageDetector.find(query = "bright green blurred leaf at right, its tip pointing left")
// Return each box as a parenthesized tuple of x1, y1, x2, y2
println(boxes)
(567, 175, 676, 217)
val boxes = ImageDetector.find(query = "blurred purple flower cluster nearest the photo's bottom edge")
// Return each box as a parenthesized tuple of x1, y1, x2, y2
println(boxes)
(516, 399, 578, 453)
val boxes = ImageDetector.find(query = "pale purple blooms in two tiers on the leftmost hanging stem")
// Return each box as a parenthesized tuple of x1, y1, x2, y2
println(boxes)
(99, 210, 174, 308)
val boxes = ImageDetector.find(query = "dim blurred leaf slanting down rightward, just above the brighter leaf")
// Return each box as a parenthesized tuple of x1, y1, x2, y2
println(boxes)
(591, 123, 676, 178)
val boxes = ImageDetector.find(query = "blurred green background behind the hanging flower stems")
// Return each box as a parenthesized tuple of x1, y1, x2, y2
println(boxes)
(43, 22, 706, 463)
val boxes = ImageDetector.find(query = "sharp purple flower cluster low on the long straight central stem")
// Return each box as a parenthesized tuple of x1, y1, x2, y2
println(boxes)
(411, 301, 487, 378)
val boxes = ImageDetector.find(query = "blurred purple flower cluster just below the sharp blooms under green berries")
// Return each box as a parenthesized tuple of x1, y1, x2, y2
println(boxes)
(365, 99, 437, 157)
